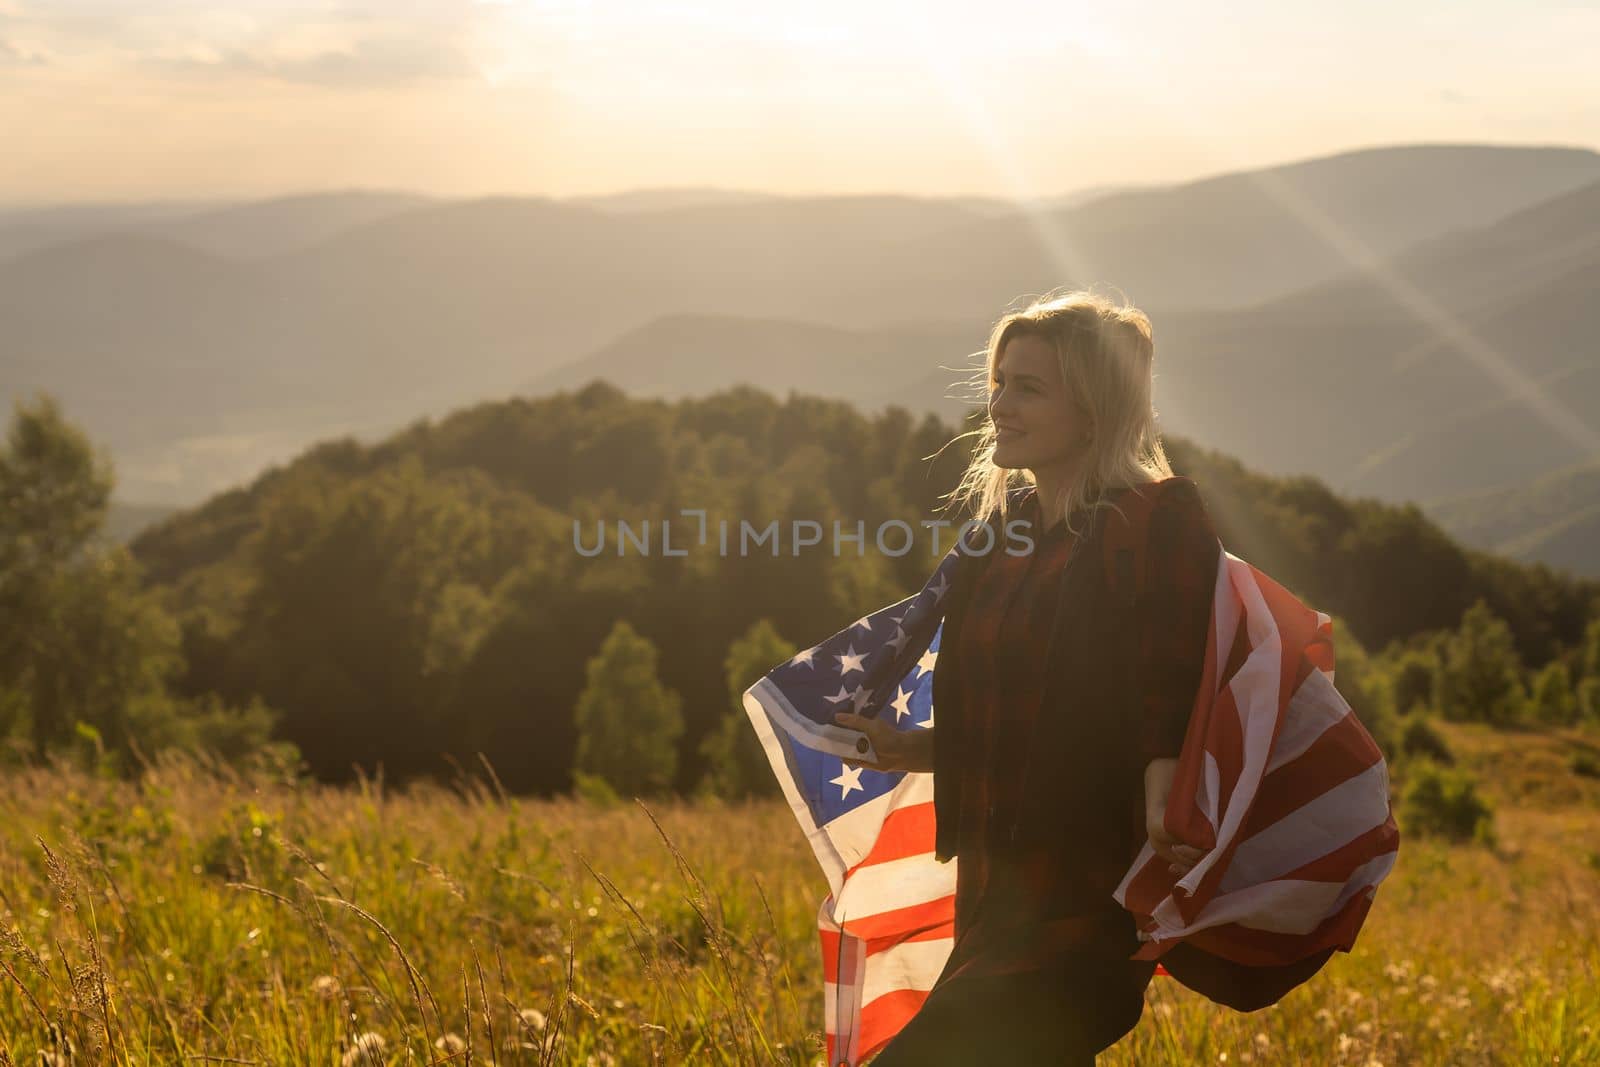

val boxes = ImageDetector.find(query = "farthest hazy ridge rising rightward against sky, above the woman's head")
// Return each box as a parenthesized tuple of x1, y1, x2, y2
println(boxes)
(883, 146, 1600, 315)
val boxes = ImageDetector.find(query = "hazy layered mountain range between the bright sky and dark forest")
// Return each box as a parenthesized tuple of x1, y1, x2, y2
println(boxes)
(0, 146, 1600, 573)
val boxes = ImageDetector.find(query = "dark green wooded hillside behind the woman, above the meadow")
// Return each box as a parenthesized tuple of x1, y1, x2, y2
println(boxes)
(0, 381, 1600, 793)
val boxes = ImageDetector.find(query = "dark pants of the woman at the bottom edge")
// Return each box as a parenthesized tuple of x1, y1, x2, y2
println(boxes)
(872, 953, 1155, 1067)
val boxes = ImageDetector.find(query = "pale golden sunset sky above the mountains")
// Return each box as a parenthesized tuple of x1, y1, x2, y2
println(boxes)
(0, 0, 1600, 205)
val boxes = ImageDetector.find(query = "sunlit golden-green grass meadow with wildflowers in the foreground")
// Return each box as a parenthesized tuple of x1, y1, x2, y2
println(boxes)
(0, 726, 1600, 1067)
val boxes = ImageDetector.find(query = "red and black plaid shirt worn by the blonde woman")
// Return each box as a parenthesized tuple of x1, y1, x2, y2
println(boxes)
(941, 478, 1221, 976)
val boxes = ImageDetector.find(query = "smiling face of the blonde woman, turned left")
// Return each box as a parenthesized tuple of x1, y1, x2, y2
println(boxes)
(989, 336, 1090, 475)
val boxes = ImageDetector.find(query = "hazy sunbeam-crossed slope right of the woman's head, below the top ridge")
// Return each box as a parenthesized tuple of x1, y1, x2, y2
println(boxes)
(1157, 175, 1600, 499)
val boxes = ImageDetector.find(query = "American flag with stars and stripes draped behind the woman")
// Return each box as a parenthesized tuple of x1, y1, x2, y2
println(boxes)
(744, 542, 1398, 1065)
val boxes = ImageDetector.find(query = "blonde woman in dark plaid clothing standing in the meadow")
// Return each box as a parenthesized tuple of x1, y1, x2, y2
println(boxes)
(837, 291, 1221, 1067)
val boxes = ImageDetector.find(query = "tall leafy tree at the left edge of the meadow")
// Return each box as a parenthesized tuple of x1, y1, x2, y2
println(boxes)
(0, 394, 272, 771)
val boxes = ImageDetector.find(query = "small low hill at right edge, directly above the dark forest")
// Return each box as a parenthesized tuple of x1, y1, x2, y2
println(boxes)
(1424, 464, 1600, 577)
